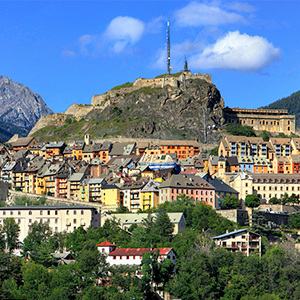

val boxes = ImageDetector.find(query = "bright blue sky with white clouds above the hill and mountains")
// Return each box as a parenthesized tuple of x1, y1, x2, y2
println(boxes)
(0, 0, 300, 112)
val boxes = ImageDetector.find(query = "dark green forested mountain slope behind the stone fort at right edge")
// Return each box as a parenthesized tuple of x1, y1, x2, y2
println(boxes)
(263, 91, 300, 128)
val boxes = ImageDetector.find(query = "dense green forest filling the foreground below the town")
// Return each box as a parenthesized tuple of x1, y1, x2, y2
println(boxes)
(0, 196, 300, 300)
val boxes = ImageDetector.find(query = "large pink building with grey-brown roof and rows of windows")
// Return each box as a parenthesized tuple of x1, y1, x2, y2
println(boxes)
(159, 175, 216, 209)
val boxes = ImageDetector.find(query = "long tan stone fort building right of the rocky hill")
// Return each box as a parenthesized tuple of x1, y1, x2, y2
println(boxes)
(224, 107, 295, 135)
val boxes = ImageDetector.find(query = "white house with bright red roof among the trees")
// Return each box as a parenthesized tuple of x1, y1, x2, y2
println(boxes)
(97, 241, 176, 266)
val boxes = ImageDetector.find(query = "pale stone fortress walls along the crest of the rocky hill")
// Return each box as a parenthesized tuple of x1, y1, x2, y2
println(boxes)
(91, 70, 212, 109)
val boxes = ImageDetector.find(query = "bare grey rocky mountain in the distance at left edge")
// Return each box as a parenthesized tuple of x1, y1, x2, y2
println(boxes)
(0, 75, 53, 141)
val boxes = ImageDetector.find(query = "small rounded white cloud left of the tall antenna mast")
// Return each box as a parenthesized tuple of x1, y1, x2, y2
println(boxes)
(103, 16, 145, 53)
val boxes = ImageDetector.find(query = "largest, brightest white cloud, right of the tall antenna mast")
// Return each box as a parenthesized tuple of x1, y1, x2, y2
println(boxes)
(189, 31, 281, 73)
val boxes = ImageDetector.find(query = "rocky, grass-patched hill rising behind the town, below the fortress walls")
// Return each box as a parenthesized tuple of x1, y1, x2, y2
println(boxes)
(30, 78, 224, 145)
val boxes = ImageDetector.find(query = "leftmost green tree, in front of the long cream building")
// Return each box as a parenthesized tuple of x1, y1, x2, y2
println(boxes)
(3, 218, 20, 255)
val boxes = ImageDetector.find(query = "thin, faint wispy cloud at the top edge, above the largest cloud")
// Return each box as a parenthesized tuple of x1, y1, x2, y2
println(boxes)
(175, 1, 246, 27)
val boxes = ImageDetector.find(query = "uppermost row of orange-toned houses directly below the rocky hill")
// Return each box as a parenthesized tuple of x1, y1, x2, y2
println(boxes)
(11, 134, 200, 163)
